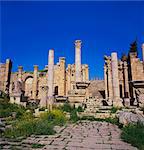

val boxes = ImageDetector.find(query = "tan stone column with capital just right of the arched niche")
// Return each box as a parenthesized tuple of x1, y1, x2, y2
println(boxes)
(32, 65, 38, 100)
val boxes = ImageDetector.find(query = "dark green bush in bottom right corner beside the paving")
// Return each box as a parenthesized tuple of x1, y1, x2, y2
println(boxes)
(121, 124, 144, 150)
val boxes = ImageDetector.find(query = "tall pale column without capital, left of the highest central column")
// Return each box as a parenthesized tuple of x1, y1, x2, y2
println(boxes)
(48, 49, 54, 110)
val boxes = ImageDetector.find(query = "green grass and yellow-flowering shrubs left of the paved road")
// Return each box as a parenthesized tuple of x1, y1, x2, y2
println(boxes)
(4, 110, 67, 139)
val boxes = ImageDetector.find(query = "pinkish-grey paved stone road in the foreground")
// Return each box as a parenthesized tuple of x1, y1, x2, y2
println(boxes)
(0, 121, 137, 150)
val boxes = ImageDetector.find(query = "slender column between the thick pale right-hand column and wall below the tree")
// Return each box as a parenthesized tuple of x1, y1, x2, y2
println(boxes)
(124, 61, 129, 98)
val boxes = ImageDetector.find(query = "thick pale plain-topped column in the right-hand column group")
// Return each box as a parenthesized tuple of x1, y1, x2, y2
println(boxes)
(111, 53, 123, 107)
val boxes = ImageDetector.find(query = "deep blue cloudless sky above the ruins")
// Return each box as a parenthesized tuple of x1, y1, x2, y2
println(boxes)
(0, 1, 144, 78)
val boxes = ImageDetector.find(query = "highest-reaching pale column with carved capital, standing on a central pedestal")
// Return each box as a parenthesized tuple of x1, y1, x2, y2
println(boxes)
(75, 40, 82, 82)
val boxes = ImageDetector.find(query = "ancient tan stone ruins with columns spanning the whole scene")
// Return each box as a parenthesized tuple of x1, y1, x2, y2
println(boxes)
(0, 40, 144, 112)
